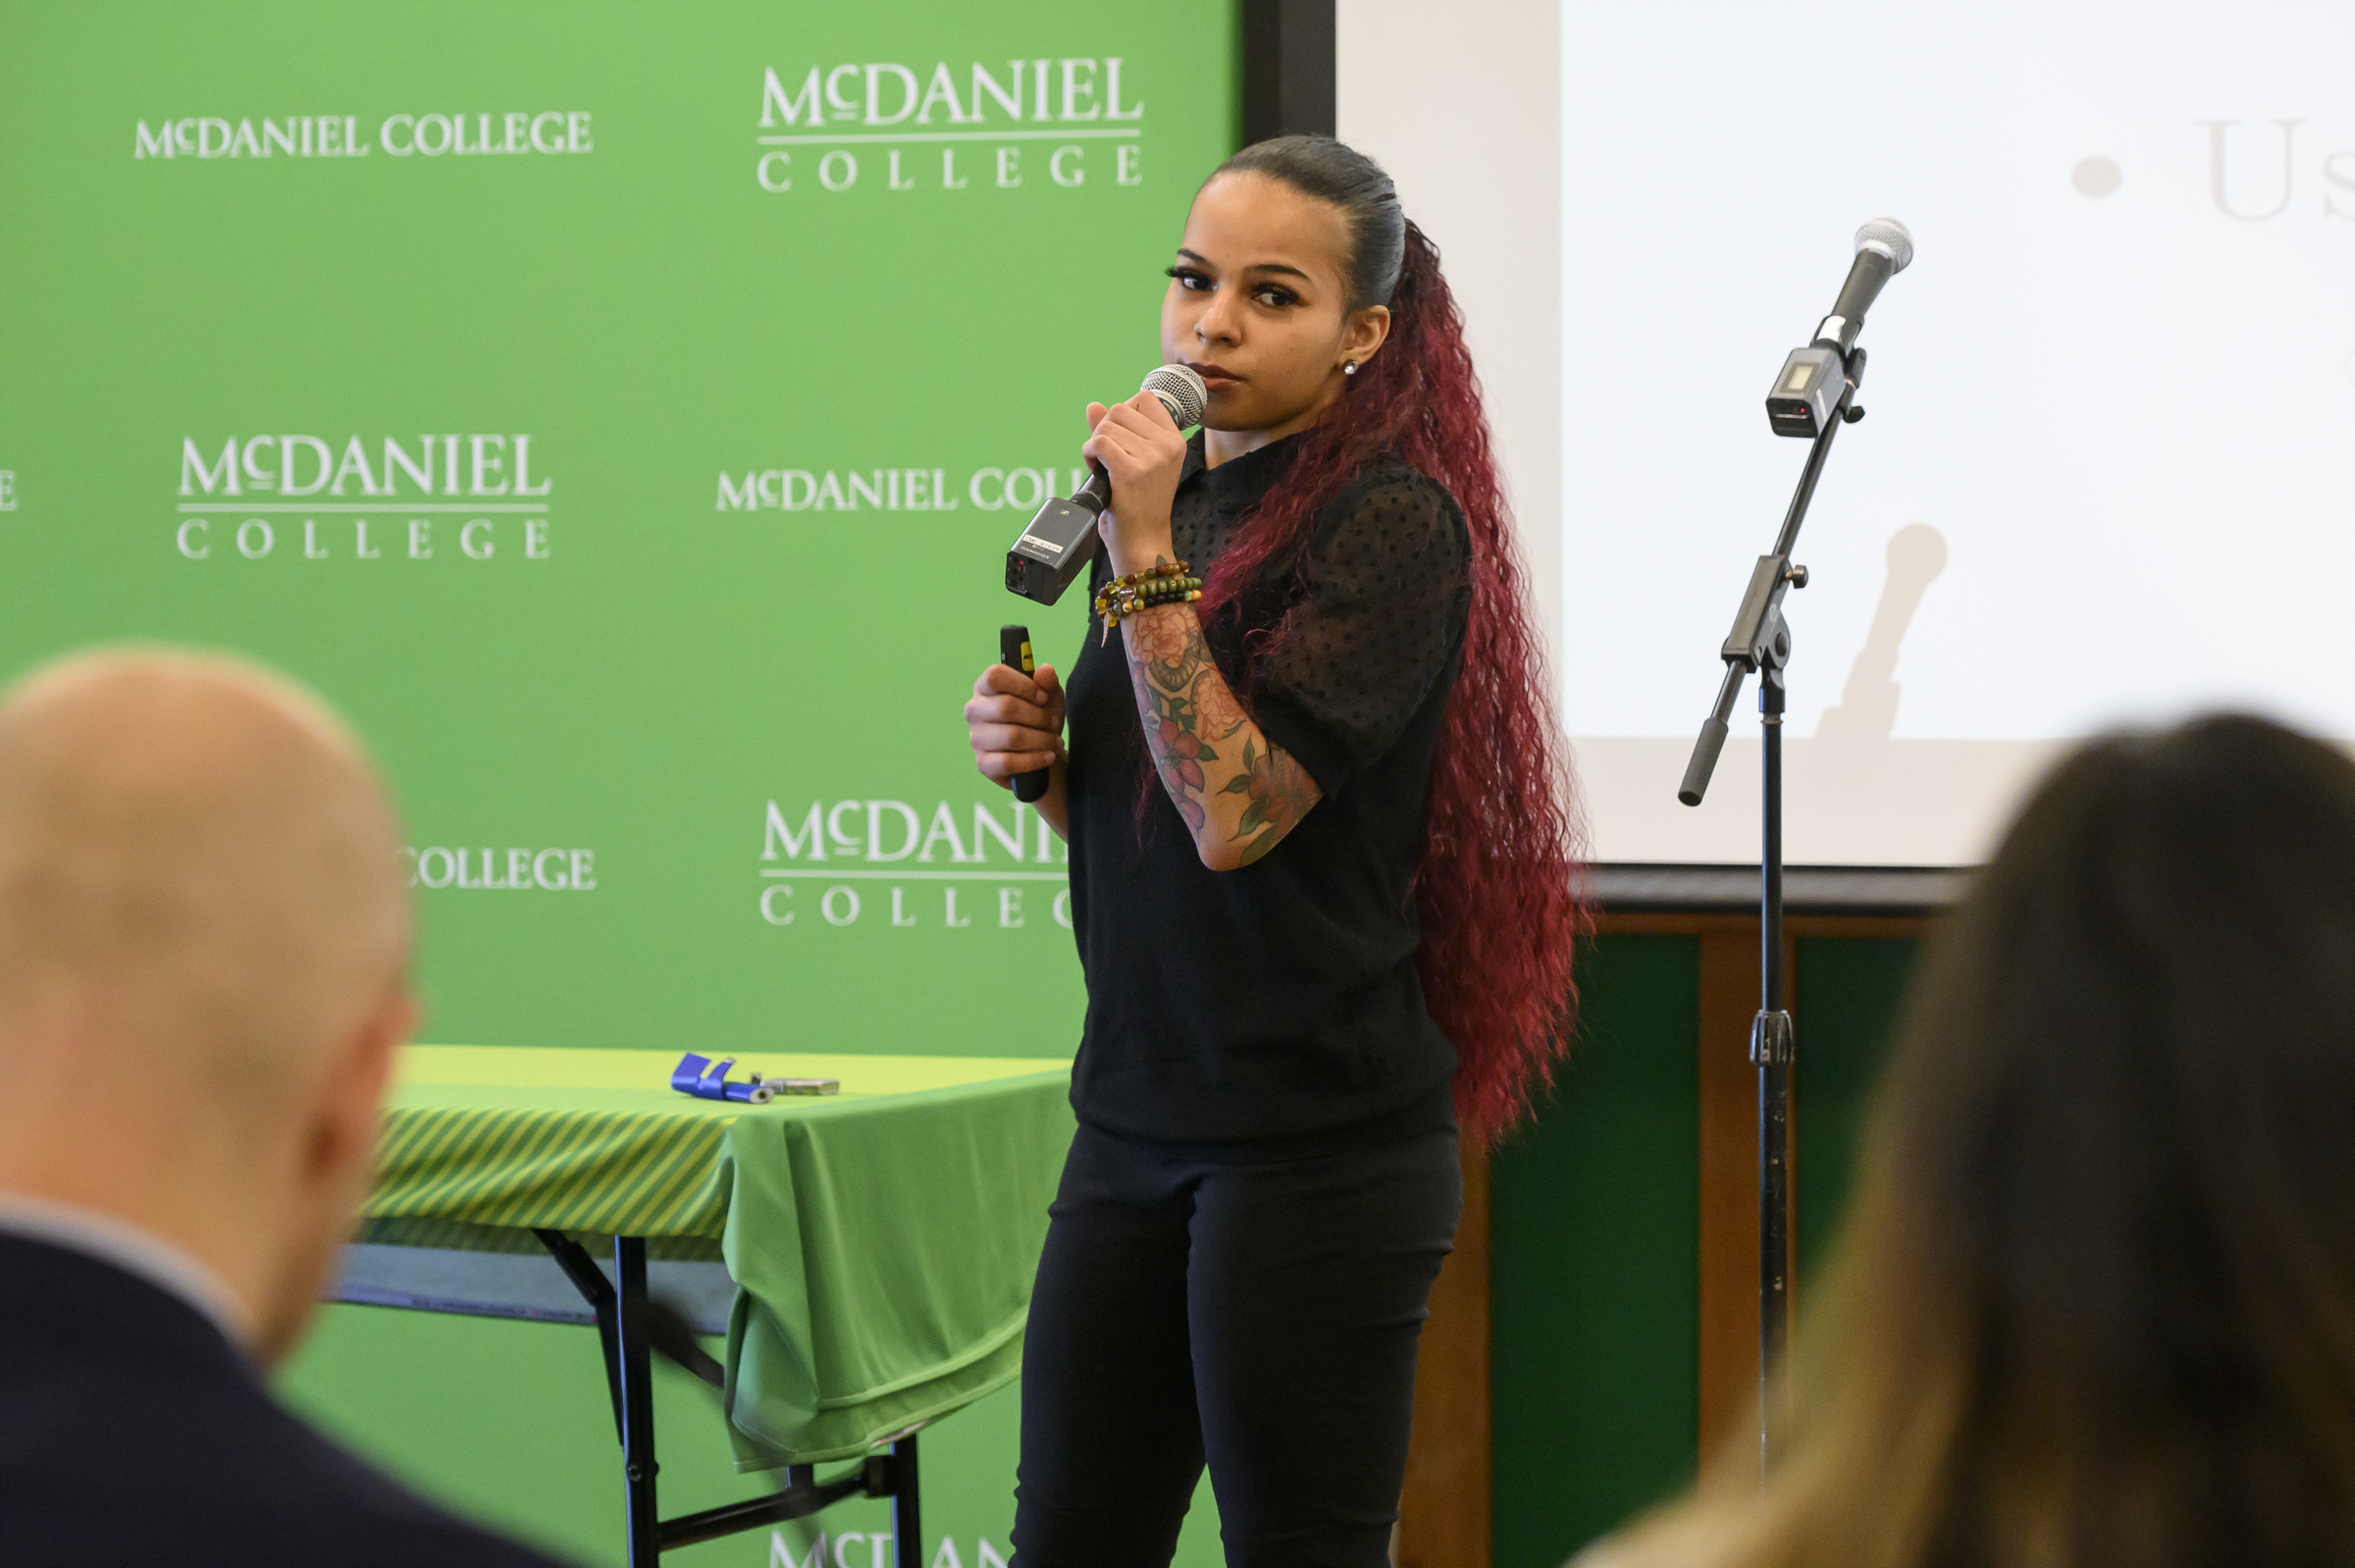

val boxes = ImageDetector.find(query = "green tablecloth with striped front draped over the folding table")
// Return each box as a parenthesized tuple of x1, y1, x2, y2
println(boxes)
(363, 1045, 1072, 1469)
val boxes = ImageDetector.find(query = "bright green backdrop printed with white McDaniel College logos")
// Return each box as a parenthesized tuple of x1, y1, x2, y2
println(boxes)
(0, 0, 1238, 1568)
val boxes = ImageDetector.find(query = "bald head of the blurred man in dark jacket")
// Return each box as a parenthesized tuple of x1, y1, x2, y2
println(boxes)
(0, 650, 414, 1363)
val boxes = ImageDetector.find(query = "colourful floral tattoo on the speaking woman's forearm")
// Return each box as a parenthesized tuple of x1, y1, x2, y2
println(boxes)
(1121, 588, 1321, 866)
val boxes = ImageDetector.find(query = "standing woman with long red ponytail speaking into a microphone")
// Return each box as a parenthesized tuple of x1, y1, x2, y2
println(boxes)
(966, 136, 1583, 1568)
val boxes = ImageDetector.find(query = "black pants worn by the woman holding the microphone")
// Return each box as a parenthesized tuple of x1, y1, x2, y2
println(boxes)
(1015, 1127, 1462, 1568)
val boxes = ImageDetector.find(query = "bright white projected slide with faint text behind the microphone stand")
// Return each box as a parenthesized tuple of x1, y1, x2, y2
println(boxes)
(1561, 0, 2355, 864)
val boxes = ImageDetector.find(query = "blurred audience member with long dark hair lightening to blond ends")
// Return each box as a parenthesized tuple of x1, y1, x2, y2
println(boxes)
(1588, 718, 2355, 1568)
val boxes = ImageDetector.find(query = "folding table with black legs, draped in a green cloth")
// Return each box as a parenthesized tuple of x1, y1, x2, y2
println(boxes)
(335, 1045, 1072, 1568)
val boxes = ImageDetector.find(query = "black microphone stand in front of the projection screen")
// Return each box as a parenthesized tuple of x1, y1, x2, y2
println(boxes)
(1677, 348, 1865, 1476)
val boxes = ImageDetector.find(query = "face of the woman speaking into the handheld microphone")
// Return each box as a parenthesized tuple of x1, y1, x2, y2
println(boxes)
(1161, 175, 1389, 436)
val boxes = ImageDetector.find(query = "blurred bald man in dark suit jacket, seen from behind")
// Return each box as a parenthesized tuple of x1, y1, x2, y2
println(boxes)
(0, 653, 567, 1568)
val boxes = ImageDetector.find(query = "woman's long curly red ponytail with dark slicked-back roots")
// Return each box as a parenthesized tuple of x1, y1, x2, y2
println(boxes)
(1201, 136, 1590, 1142)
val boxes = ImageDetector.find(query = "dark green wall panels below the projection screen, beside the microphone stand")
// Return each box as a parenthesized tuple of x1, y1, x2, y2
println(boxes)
(1491, 937, 1914, 1568)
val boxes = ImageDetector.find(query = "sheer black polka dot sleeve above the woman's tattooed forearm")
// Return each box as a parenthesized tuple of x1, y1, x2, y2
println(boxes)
(1253, 456, 1472, 796)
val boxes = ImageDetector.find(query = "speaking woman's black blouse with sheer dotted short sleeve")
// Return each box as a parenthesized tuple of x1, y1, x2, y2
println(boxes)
(1067, 436, 1472, 1159)
